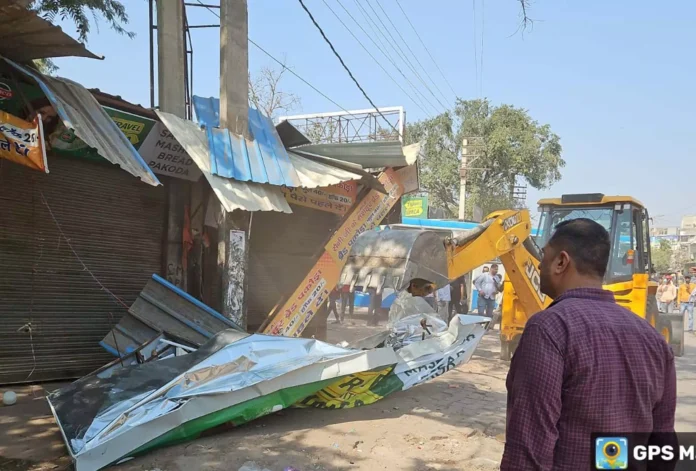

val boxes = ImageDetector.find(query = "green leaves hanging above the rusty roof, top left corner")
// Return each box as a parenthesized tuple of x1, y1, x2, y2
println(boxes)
(31, 0, 135, 42)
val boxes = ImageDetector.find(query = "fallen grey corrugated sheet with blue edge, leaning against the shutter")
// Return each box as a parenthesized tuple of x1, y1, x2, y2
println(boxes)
(100, 275, 243, 356)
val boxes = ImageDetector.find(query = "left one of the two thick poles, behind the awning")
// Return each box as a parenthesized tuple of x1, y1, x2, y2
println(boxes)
(157, 0, 189, 290)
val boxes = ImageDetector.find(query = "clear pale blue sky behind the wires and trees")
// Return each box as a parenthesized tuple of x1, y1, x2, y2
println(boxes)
(51, 0, 696, 225)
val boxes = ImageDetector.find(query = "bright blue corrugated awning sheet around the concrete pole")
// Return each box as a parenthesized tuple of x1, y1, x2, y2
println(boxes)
(193, 96, 303, 187)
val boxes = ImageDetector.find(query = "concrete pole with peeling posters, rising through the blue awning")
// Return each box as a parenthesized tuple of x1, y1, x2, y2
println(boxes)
(218, 0, 251, 329)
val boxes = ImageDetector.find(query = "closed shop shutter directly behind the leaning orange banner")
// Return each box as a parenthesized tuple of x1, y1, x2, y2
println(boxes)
(247, 205, 341, 331)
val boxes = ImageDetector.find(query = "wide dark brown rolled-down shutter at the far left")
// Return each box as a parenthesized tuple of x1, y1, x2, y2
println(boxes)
(0, 157, 166, 384)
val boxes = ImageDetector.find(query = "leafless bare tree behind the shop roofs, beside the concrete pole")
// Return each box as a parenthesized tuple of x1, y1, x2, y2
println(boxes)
(249, 61, 300, 118)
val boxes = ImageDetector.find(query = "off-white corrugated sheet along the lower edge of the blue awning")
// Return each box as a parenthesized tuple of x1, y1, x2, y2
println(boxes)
(157, 111, 292, 213)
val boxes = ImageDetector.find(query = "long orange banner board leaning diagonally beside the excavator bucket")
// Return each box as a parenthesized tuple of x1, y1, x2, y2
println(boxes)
(264, 168, 403, 337)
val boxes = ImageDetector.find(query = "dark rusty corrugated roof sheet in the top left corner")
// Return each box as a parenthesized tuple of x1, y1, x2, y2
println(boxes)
(0, 0, 103, 62)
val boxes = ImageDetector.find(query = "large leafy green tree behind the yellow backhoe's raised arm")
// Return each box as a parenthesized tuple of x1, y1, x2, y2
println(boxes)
(406, 99, 565, 219)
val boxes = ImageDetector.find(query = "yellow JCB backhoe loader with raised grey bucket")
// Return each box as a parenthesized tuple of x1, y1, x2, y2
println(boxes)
(341, 194, 684, 360)
